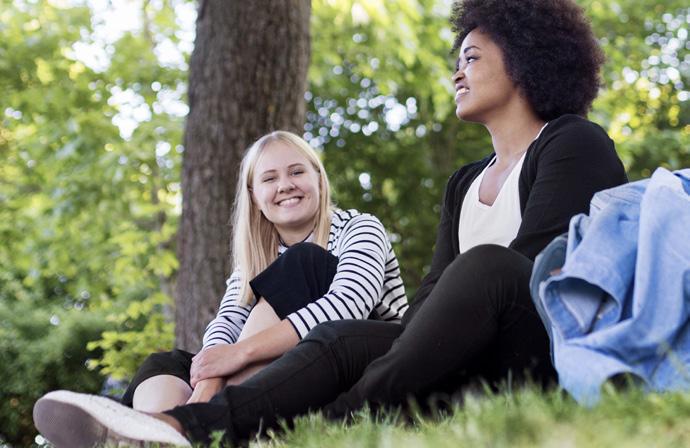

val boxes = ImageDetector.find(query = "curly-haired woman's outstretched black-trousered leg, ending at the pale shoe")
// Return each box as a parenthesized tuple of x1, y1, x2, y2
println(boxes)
(166, 320, 402, 442)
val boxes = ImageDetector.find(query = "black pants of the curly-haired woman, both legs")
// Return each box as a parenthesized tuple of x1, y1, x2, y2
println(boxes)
(161, 245, 555, 441)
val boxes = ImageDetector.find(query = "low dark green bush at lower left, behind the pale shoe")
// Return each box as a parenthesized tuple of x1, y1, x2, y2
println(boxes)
(0, 300, 107, 446)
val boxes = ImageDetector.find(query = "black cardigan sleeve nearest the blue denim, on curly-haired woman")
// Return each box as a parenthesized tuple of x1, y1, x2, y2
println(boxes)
(509, 116, 627, 260)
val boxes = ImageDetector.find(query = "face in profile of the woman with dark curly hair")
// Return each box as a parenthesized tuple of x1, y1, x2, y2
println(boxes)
(452, 29, 521, 124)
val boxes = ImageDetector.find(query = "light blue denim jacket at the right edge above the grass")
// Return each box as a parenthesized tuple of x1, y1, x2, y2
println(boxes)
(531, 168, 690, 405)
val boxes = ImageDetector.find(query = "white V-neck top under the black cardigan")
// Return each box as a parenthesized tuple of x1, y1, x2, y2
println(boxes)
(458, 153, 526, 253)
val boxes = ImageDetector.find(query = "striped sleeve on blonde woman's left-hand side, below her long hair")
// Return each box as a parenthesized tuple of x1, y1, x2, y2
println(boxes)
(203, 271, 252, 348)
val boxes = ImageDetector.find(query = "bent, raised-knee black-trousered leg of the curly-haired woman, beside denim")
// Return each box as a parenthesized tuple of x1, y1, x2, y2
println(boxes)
(324, 245, 555, 417)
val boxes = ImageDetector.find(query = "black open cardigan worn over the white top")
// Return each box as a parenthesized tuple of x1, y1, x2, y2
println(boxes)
(403, 115, 627, 324)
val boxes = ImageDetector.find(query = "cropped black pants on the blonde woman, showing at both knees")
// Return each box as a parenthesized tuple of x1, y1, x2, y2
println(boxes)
(121, 243, 338, 407)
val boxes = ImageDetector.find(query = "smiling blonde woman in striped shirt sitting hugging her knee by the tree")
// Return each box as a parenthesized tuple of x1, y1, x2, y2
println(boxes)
(117, 131, 407, 412)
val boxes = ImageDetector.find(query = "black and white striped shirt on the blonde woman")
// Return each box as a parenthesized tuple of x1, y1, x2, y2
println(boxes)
(204, 210, 407, 347)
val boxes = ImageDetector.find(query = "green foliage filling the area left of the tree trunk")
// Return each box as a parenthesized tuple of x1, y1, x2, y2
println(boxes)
(0, 0, 186, 440)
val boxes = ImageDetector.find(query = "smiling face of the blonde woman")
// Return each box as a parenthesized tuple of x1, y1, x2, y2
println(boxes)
(251, 140, 320, 244)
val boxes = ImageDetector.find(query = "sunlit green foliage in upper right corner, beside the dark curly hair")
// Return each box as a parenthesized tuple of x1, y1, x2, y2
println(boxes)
(580, 0, 690, 179)
